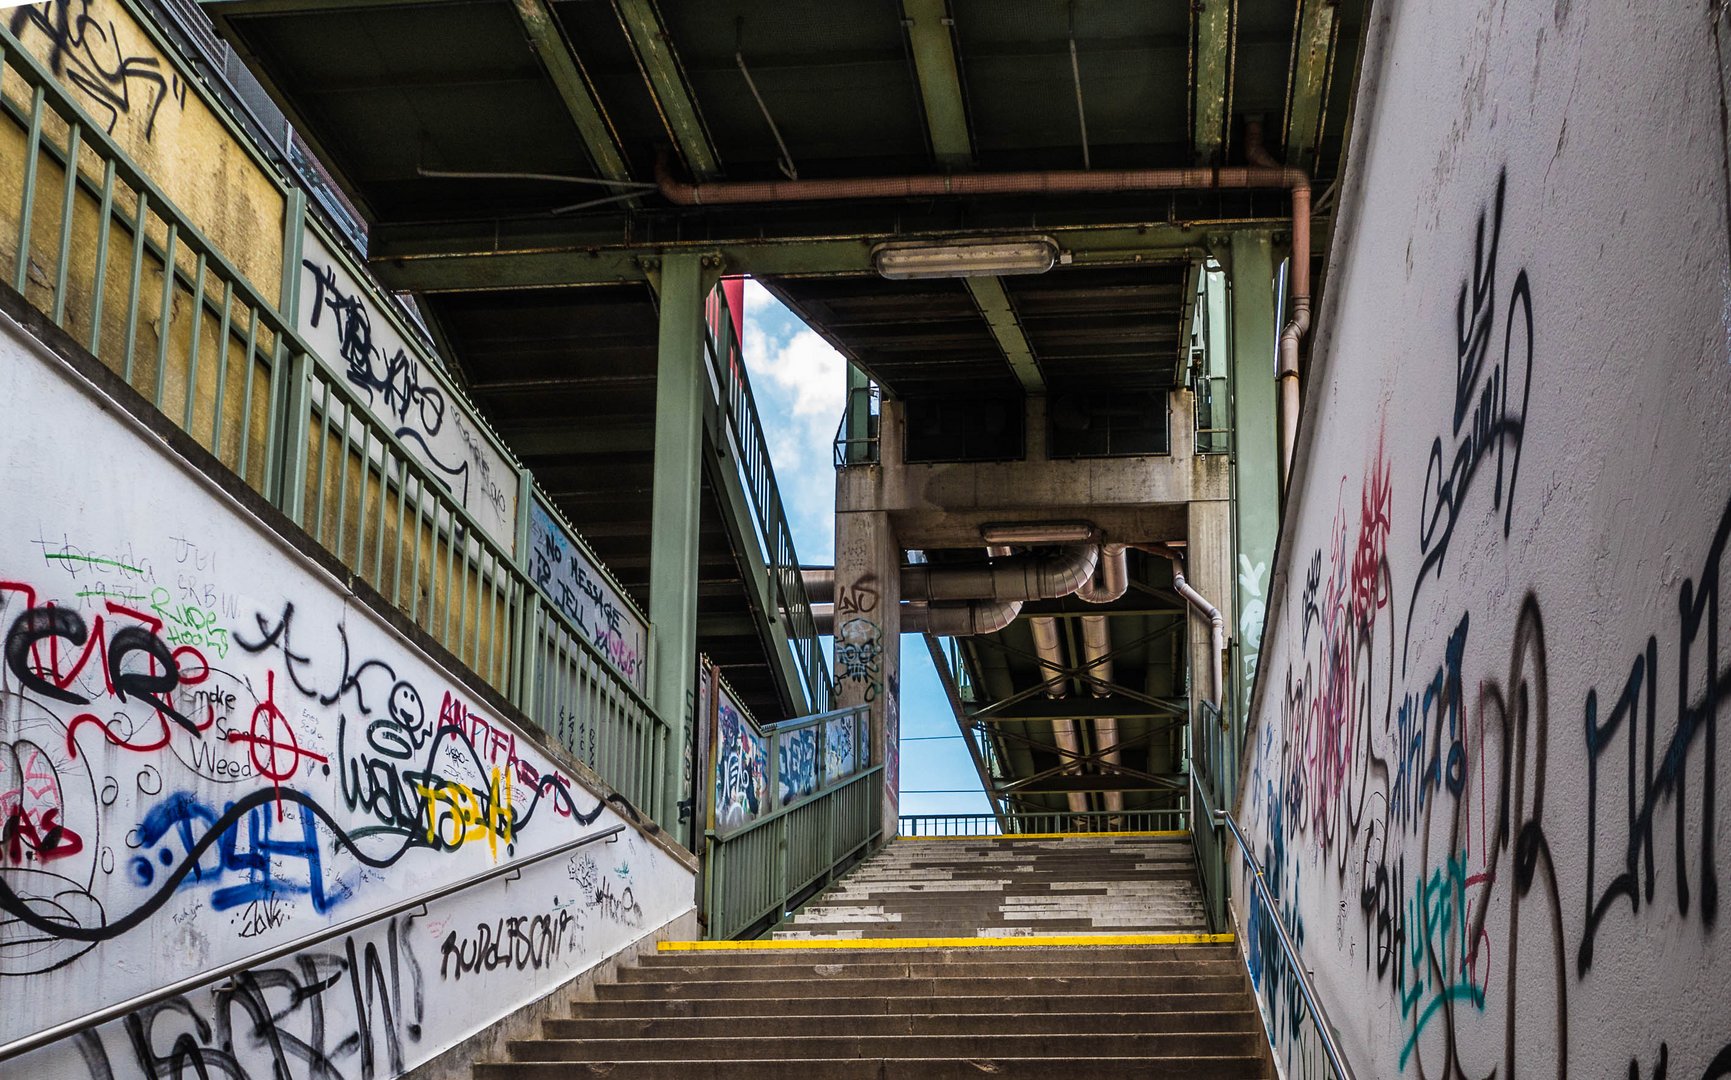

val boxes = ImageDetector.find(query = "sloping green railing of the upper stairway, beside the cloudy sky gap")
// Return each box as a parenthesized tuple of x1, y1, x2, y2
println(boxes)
(706, 289, 829, 708)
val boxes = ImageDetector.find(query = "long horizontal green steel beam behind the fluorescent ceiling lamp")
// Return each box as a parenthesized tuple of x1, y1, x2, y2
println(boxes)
(370, 222, 1218, 293)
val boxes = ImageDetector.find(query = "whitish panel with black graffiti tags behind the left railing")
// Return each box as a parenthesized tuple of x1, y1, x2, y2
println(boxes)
(298, 228, 518, 550)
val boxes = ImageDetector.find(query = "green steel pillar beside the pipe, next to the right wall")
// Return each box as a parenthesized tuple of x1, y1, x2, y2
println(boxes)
(1215, 232, 1281, 730)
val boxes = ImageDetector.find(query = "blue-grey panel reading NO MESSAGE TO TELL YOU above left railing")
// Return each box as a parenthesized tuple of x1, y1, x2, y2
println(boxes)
(530, 500, 649, 691)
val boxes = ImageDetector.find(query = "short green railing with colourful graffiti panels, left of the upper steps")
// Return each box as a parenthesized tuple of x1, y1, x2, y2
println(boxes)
(703, 706, 883, 938)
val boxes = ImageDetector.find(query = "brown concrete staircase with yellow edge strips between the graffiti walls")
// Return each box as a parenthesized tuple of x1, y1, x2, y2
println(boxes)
(474, 838, 1274, 1080)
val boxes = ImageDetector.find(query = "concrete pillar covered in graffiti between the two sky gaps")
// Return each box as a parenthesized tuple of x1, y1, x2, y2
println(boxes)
(834, 498, 902, 838)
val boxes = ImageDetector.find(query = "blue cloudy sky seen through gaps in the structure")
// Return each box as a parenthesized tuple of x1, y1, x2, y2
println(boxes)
(744, 282, 990, 813)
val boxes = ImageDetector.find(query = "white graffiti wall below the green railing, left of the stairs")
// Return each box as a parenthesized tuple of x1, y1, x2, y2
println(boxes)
(0, 308, 692, 1080)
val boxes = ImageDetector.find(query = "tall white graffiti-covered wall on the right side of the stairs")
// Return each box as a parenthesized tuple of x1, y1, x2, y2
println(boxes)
(1234, 8, 1731, 1080)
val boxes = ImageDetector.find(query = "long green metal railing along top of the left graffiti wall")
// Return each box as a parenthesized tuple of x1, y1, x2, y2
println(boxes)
(0, 26, 677, 822)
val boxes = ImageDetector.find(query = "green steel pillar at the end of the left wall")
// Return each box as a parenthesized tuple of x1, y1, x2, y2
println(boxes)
(649, 254, 708, 843)
